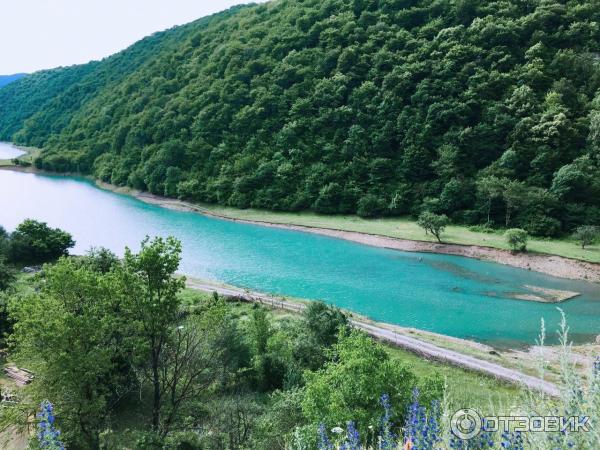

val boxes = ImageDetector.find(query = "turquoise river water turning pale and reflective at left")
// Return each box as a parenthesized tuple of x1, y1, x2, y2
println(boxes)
(0, 165, 600, 346)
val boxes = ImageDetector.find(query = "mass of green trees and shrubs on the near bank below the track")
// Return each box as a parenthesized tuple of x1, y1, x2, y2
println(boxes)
(5, 239, 548, 450)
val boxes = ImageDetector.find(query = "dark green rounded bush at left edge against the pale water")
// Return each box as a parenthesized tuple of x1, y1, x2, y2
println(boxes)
(8, 219, 75, 264)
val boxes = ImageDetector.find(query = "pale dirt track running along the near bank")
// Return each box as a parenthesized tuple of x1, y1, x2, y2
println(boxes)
(187, 280, 560, 397)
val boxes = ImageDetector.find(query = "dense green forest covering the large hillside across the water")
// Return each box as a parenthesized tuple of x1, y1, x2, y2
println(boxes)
(0, 0, 600, 235)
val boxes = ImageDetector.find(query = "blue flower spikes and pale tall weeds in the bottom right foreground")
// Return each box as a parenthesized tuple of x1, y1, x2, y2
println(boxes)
(314, 311, 600, 450)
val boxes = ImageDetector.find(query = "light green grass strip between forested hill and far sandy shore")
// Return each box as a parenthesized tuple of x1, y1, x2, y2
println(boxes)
(197, 205, 600, 263)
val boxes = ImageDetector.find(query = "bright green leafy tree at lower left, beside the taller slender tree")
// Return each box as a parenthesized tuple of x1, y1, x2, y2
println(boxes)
(9, 259, 127, 448)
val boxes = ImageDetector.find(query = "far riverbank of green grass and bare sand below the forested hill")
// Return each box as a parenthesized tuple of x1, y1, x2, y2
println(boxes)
(0, 166, 600, 284)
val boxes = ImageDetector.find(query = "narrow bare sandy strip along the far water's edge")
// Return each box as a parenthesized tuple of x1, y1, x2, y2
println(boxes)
(0, 166, 600, 283)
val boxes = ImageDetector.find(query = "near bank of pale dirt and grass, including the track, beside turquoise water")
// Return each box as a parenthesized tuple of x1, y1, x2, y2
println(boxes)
(187, 278, 600, 396)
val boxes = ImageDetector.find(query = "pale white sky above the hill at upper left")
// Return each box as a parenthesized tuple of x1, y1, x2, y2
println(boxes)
(0, 0, 264, 75)
